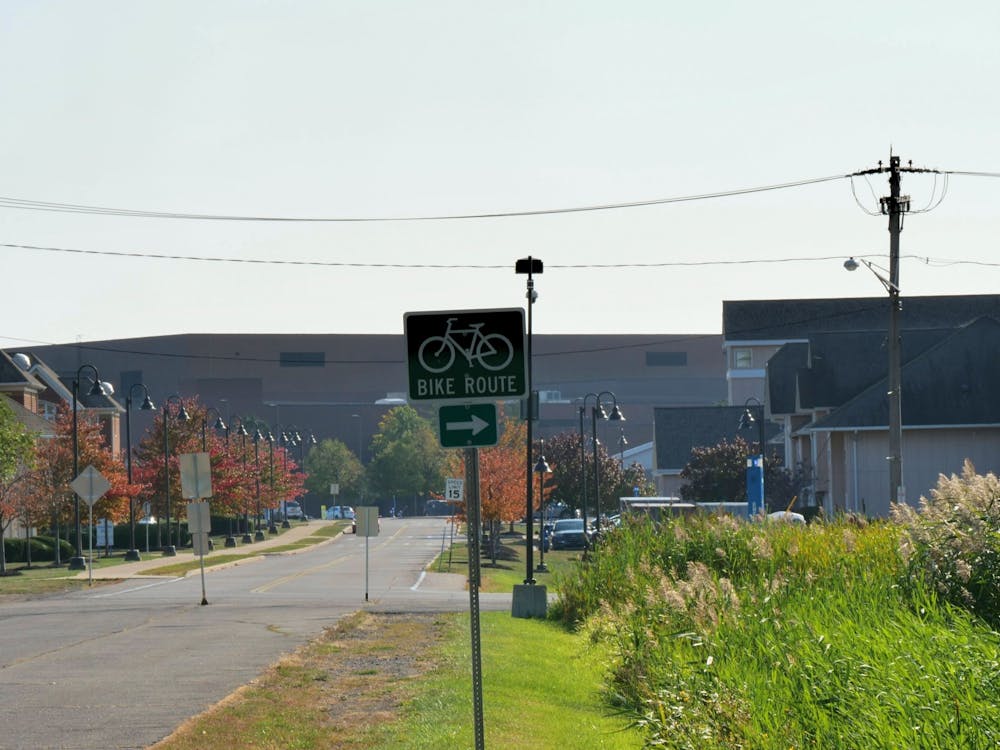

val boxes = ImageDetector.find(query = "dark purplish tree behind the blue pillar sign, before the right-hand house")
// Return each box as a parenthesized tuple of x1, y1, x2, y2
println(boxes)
(681, 437, 802, 510)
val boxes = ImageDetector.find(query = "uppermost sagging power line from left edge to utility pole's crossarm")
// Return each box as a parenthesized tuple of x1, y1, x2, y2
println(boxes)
(0, 175, 849, 223)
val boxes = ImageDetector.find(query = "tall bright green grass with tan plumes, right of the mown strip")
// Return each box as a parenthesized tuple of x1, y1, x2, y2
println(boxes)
(554, 517, 1000, 749)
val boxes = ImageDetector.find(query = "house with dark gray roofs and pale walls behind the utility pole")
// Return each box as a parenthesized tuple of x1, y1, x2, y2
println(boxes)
(655, 295, 1000, 516)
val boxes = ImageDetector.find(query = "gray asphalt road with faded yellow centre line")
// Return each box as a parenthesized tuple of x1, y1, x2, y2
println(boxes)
(0, 518, 510, 750)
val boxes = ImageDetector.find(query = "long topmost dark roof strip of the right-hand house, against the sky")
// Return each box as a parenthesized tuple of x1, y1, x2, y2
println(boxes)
(722, 294, 1000, 341)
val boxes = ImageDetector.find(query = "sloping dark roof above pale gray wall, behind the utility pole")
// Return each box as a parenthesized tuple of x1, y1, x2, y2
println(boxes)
(813, 317, 1000, 429)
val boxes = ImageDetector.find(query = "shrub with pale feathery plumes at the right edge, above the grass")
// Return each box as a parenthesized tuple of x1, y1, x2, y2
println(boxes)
(892, 461, 1000, 628)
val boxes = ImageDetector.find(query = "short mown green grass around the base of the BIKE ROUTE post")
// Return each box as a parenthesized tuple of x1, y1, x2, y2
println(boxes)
(357, 612, 641, 750)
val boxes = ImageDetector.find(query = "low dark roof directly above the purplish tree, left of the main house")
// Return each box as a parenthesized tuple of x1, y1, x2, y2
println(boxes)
(653, 406, 781, 470)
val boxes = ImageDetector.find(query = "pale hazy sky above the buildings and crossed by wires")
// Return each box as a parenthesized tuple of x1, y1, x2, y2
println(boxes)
(0, 0, 1000, 349)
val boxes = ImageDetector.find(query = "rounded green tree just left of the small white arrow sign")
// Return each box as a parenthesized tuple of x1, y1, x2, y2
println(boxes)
(368, 406, 446, 508)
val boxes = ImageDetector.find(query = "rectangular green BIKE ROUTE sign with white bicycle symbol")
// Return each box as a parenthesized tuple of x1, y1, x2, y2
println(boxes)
(403, 308, 528, 402)
